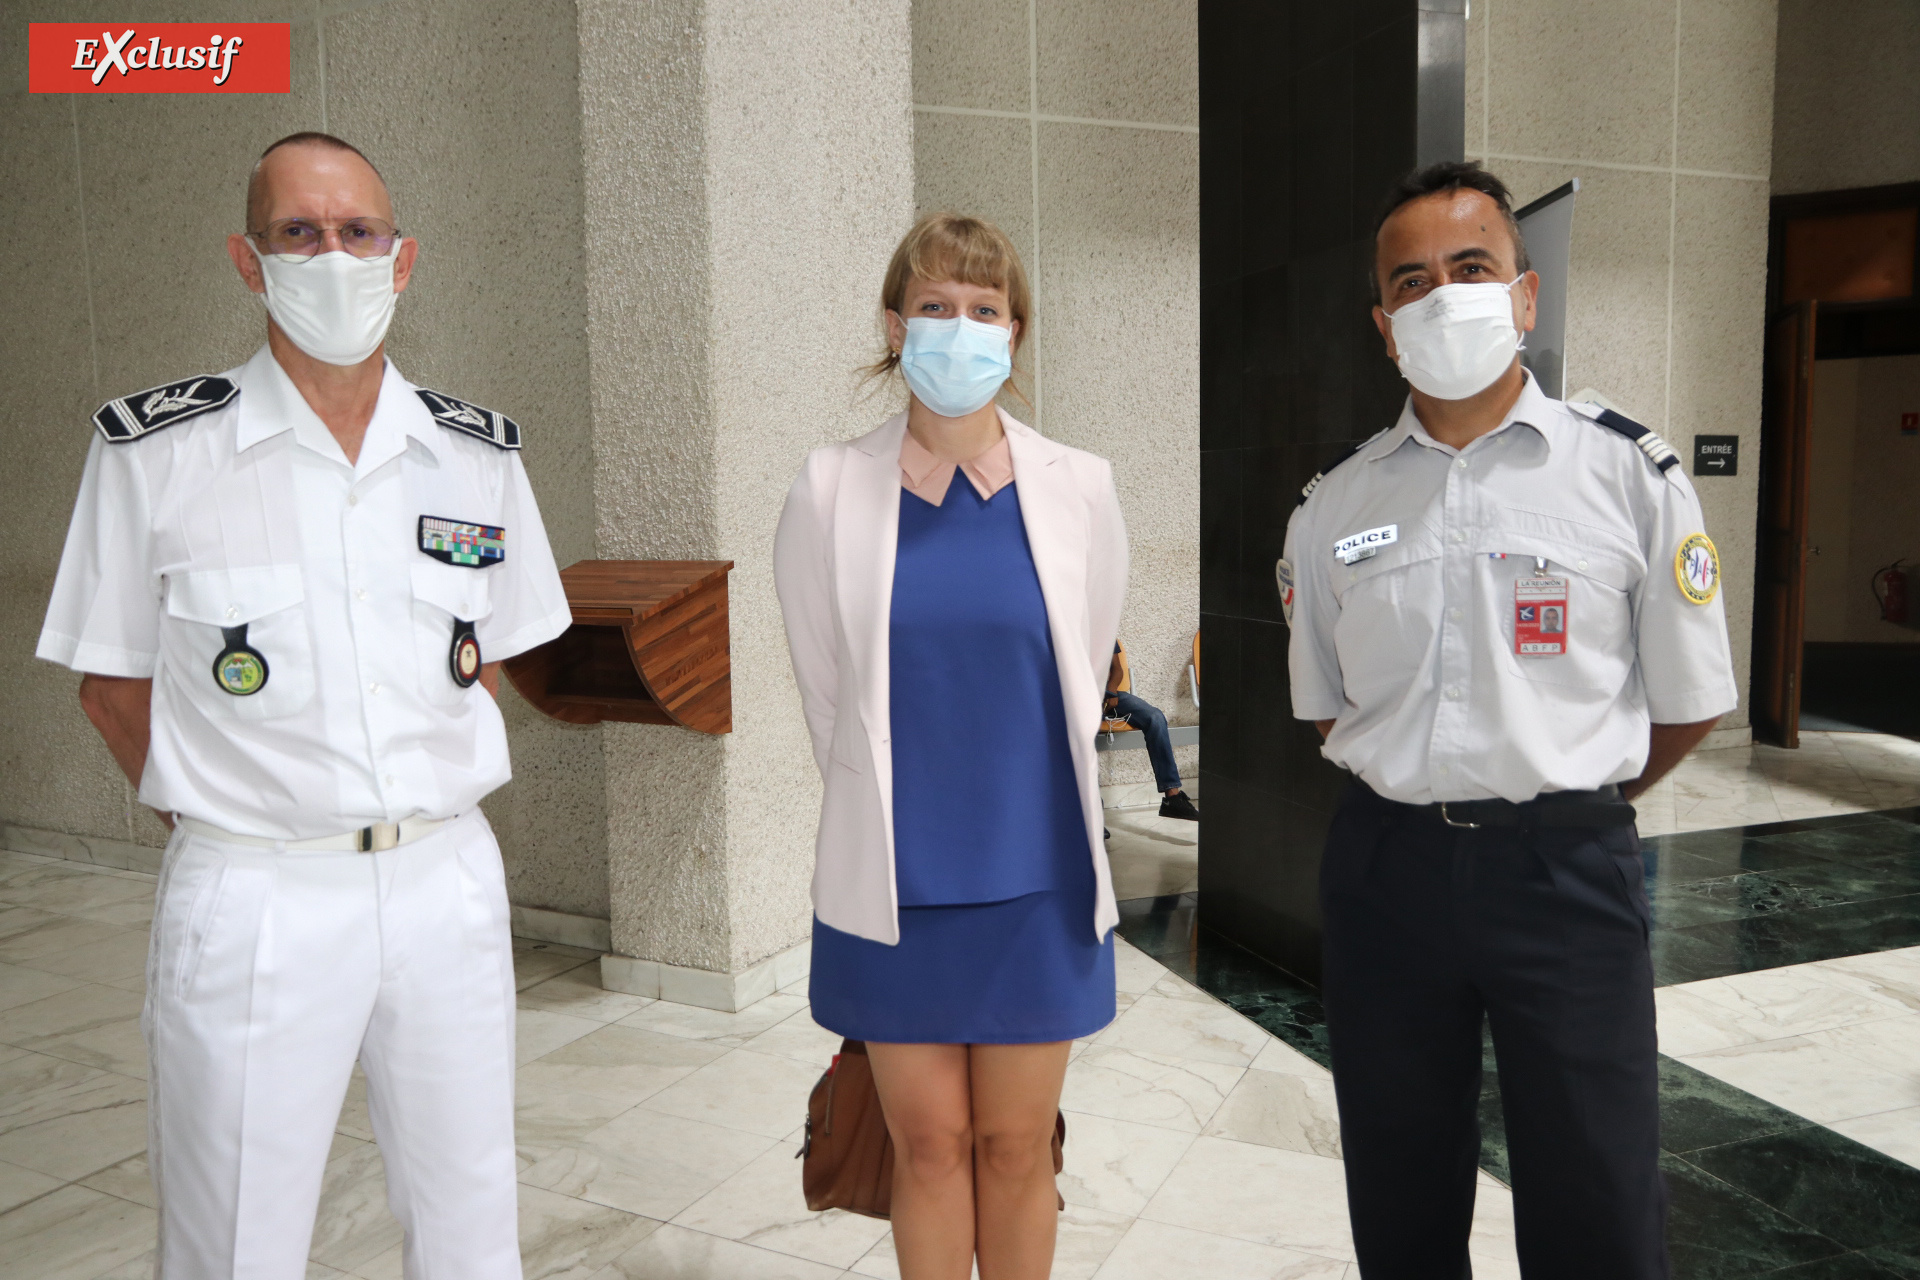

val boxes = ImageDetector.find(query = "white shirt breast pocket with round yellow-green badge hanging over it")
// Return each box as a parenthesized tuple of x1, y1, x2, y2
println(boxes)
(167, 564, 313, 720)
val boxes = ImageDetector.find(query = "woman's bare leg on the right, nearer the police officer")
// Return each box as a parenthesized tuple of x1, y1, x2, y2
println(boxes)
(970, 1040, 1073, 1280)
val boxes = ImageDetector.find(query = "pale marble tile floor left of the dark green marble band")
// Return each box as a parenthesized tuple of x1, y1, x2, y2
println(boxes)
(0, 844, 1519, 1280)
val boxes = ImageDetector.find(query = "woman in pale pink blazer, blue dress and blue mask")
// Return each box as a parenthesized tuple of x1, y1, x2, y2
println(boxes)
(774, 215, 1127, 1280)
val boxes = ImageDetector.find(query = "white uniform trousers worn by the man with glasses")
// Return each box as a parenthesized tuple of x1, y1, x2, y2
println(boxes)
(144, 810, 520, 1280)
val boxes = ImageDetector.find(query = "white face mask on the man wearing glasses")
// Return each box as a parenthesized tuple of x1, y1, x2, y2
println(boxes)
(253, 244, 399, 365)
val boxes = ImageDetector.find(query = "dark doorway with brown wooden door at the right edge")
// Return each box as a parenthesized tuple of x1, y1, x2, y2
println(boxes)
(1753, 182, 1920, 747)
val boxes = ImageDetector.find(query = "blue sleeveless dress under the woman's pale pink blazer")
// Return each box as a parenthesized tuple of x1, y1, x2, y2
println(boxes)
(808, 470, 1114, 1044)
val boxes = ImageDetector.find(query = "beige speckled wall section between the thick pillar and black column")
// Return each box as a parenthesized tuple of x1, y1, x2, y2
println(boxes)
(914, 0, 1200, 781)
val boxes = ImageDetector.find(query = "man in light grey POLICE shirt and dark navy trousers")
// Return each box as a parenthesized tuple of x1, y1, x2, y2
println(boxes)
(1279, 163, 1738, 1280)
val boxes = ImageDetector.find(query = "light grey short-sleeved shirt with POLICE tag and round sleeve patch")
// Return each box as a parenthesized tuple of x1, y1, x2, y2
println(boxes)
(1286, 376, 1740, 804)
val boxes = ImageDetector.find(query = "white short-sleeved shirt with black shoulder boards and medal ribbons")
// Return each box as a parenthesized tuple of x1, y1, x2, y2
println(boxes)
(36, 339, 570, 839)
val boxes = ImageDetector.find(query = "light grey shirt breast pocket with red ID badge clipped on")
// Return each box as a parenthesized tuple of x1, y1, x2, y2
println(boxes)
(1480, 533, 1634, 695)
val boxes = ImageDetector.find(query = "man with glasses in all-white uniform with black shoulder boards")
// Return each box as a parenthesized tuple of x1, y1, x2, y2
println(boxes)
(38, 134, 570, 1280)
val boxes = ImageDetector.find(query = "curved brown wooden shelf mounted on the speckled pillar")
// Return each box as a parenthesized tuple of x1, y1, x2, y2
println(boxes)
(503, 560, 733, 733)
